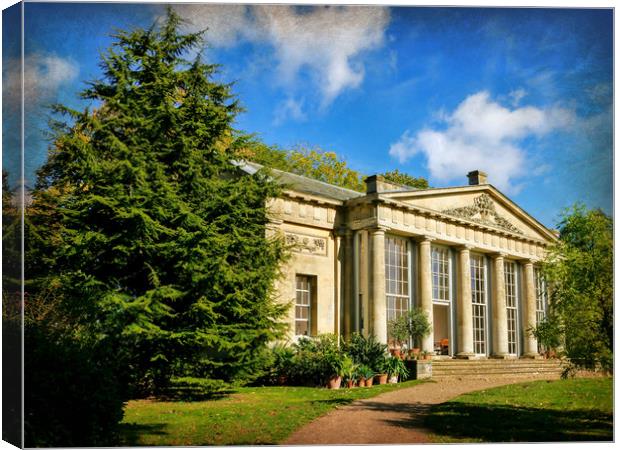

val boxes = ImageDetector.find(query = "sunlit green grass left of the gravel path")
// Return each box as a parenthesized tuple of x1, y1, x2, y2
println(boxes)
(122, 381, 420, 446)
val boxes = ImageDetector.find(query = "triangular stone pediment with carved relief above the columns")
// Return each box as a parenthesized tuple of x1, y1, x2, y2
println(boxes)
(381, 185, 555, 241)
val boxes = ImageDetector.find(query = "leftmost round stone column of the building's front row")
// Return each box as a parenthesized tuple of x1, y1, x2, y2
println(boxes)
(369, 228, 387, 344)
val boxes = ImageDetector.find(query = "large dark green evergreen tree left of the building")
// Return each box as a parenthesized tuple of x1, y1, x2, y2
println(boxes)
(29, 10, 284, 391)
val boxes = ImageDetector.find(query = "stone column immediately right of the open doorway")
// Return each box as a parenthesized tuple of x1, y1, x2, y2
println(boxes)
(456, 245, 475, 358)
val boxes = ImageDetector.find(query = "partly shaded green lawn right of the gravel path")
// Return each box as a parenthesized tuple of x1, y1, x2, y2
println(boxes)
(425, 378, 613, 442)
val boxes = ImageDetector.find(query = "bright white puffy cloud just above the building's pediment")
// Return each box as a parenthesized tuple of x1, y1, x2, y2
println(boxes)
(390, 91, 576, 193)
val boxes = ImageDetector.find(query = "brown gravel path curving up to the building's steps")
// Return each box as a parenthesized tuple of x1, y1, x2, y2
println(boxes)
(283, 375, 558, 445)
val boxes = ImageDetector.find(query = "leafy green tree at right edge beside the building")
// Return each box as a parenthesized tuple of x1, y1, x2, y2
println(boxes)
(543, 205, 613, 368)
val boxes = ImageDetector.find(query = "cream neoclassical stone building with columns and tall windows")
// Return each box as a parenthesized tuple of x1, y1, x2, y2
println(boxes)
(244, 164, 556, 358)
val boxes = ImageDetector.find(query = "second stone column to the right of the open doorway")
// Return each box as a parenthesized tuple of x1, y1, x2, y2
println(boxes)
(491, 253, 508, 358)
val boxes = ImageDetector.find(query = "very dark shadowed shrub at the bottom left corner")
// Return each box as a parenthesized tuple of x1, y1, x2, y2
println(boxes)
(24, 322, 127, 447)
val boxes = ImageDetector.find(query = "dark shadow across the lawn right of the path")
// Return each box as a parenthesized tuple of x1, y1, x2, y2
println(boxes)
(418, 402, 613, 442)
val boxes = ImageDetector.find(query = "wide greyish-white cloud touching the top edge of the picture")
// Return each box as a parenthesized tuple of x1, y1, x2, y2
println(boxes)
(175, 5, 389, 107)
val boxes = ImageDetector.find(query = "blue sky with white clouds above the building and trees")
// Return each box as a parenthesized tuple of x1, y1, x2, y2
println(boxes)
(3, 3, 613, 226)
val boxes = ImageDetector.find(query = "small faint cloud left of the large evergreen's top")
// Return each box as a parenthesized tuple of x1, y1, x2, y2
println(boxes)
(3, 53, 79, 106)
